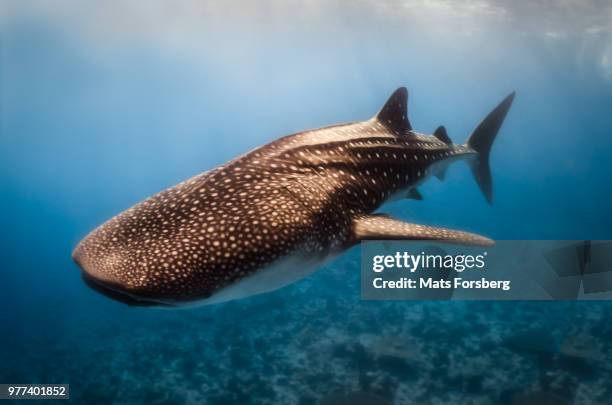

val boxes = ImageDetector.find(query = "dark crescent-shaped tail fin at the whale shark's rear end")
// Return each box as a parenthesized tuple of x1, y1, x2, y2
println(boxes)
(467, 92, 515, 204)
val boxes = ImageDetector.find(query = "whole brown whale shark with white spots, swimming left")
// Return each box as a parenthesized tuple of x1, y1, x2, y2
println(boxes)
(72, 87, 514, 306)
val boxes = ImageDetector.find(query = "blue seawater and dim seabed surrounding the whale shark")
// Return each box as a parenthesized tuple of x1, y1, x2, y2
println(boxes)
(0, 0, 612, 405)
